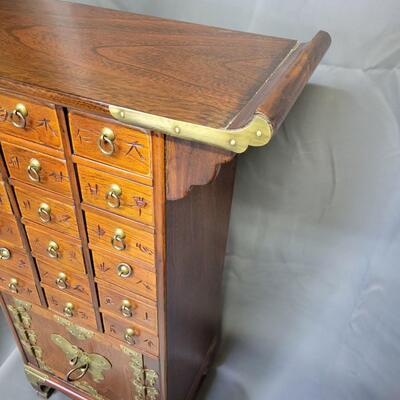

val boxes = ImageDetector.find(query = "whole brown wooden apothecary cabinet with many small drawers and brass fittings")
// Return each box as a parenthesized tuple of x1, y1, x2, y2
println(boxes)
(0, 0, 330, 400)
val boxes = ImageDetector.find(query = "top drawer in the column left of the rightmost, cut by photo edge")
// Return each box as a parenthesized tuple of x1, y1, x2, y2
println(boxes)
(0, 93, 62, 149)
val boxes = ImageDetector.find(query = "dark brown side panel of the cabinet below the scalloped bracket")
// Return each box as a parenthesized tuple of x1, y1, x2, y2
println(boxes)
(166, 160, 235, 400)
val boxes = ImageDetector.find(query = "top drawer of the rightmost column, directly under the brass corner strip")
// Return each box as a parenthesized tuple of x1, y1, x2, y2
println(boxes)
(69, 113, 151, 176)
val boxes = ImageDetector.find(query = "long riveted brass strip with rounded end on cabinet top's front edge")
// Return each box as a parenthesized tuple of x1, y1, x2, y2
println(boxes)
(109, 106, 273, 153)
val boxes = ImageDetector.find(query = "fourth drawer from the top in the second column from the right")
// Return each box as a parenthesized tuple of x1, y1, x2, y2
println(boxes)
(25, 224, 85, 272)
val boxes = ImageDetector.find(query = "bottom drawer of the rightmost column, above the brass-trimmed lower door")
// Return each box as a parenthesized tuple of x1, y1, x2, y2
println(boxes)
(102, 313, 159, 356)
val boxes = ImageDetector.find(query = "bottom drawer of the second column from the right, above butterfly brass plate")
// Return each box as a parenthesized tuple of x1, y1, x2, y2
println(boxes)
(42, 285, 97, 329)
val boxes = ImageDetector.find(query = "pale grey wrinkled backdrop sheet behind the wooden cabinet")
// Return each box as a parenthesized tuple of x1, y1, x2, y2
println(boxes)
(0, 0, 400, 400)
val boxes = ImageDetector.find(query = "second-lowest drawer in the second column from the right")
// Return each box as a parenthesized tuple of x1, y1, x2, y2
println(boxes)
(37, 260, 92, 302)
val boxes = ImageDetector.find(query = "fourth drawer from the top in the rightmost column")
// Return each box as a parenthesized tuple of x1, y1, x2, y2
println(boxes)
(92, 250, 157, 300)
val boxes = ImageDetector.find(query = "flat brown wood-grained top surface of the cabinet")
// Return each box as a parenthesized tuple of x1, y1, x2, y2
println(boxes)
(0, 0, 304, 128)
